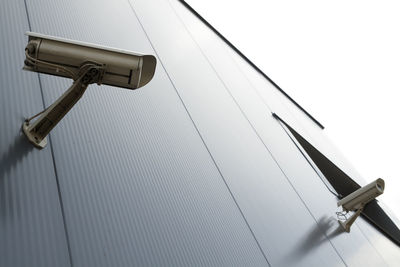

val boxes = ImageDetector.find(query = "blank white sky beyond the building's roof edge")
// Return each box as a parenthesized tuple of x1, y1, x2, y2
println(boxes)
(186, 0, 400, 218)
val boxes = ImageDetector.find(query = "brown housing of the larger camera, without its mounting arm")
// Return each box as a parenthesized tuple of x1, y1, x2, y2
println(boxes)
(23, 32, 157, 89)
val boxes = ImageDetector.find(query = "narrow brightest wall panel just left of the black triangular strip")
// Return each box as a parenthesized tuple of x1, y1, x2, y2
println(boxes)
(166, 0, 394, 266)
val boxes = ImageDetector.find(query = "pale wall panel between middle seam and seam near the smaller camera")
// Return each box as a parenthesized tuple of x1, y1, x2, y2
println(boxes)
(131, 1, 360, 266)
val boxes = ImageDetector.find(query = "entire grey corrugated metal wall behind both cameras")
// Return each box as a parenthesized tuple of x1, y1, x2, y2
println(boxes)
(0, 0, 400, 267)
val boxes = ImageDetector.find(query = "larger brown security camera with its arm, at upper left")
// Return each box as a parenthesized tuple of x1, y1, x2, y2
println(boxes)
(22, 32, 156, 148)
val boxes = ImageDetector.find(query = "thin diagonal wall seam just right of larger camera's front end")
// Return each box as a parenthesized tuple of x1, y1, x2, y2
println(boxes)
(127, 0, 271, 266)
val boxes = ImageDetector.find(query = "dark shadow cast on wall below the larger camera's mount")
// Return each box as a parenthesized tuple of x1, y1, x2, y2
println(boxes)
(0, 133, 33, 220)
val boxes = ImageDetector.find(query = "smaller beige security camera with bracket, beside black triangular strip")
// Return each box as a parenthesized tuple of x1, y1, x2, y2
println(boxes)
(337, 178, 385, 232)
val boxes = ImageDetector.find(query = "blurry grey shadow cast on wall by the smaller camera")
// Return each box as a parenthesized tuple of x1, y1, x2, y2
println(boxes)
(278, 216, 344, 266)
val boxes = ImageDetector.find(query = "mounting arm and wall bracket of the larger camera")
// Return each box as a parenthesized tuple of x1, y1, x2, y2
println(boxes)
(22, 62, 105, 149)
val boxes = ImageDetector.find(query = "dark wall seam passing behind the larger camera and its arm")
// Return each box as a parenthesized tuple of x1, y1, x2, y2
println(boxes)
(24, 0, 74, 267)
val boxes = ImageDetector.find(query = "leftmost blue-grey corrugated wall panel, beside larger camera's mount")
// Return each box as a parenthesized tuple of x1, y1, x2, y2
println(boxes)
(0, 0, 70, 267)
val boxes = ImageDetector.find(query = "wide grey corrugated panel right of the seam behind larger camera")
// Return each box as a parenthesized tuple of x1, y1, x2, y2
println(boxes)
(28, 0, 267, 266)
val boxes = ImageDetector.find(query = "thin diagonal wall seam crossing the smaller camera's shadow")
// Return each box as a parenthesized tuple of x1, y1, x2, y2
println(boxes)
(166, 0, 347, 266)
